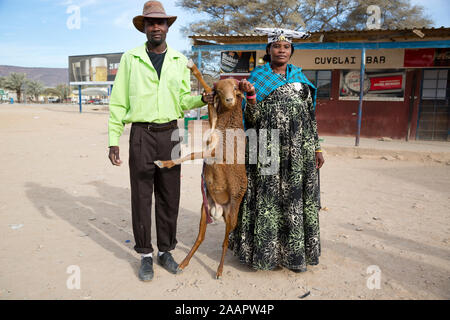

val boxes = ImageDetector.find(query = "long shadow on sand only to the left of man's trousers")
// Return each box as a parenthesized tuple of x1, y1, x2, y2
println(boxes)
(25, 182, 139, 276)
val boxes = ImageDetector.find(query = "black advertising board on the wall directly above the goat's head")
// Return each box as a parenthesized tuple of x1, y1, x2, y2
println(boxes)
(220, 51, 256, 73)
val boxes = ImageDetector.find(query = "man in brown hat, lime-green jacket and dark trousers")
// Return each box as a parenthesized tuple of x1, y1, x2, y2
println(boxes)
(108, 1, 211, 281)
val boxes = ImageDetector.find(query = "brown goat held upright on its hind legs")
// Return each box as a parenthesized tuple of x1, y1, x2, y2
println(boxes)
(155, 73, 247, 279)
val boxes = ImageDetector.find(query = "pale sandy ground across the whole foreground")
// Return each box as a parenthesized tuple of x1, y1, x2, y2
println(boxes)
(0, 105, 450, 299)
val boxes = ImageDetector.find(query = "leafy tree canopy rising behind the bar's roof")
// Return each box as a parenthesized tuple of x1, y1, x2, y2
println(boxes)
(177, 0, 432, 34)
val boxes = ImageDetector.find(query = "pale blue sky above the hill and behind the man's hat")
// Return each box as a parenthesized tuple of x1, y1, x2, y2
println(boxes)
(0, 0, 450, 68)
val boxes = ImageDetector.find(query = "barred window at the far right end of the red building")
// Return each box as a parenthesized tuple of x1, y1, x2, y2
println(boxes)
(422, 70, 448, 100)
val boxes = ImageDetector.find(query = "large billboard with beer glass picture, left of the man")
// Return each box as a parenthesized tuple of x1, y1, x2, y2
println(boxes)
(69, 53, 122, 85)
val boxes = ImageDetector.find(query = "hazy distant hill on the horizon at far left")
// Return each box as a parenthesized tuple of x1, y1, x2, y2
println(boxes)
(0, 66, 69, 87)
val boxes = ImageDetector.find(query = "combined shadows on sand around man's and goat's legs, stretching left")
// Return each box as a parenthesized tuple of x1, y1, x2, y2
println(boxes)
(25, 181, 254, 277)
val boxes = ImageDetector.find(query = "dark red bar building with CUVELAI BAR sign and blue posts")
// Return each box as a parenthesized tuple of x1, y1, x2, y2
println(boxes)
(190, 28, 450, 141)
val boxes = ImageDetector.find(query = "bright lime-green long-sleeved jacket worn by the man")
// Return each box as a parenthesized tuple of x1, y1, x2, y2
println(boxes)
(108, 44, 205, 146)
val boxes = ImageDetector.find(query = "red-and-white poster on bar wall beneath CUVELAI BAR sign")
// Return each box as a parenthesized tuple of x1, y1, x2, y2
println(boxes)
(339, 70, 405, 98)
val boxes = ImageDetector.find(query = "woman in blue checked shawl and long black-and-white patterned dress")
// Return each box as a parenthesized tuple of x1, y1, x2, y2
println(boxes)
(230, 34, 324, 272)
